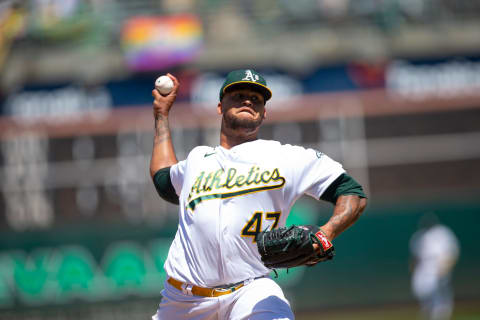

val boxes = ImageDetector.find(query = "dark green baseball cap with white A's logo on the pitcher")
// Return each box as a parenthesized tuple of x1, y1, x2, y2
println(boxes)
(220, 69, 272, 102)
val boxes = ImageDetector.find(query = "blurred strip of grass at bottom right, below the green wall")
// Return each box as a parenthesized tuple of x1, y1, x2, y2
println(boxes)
(296, 301, 480, 320)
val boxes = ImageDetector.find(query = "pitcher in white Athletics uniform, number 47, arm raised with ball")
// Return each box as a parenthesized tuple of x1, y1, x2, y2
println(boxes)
(150, 69, 366, 320)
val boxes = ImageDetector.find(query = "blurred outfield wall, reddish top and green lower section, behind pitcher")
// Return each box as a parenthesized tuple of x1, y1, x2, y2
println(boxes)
(0, 91, 480, 320)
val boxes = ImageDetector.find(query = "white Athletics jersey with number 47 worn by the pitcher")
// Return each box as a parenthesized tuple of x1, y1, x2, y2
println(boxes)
(164, 140, 345, 287)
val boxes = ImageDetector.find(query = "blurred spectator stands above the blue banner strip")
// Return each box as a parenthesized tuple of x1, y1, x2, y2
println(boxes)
(0, 0, 480, 88)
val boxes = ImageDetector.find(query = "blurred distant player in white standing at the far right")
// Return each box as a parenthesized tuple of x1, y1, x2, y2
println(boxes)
(410, 213, 460, 320)
